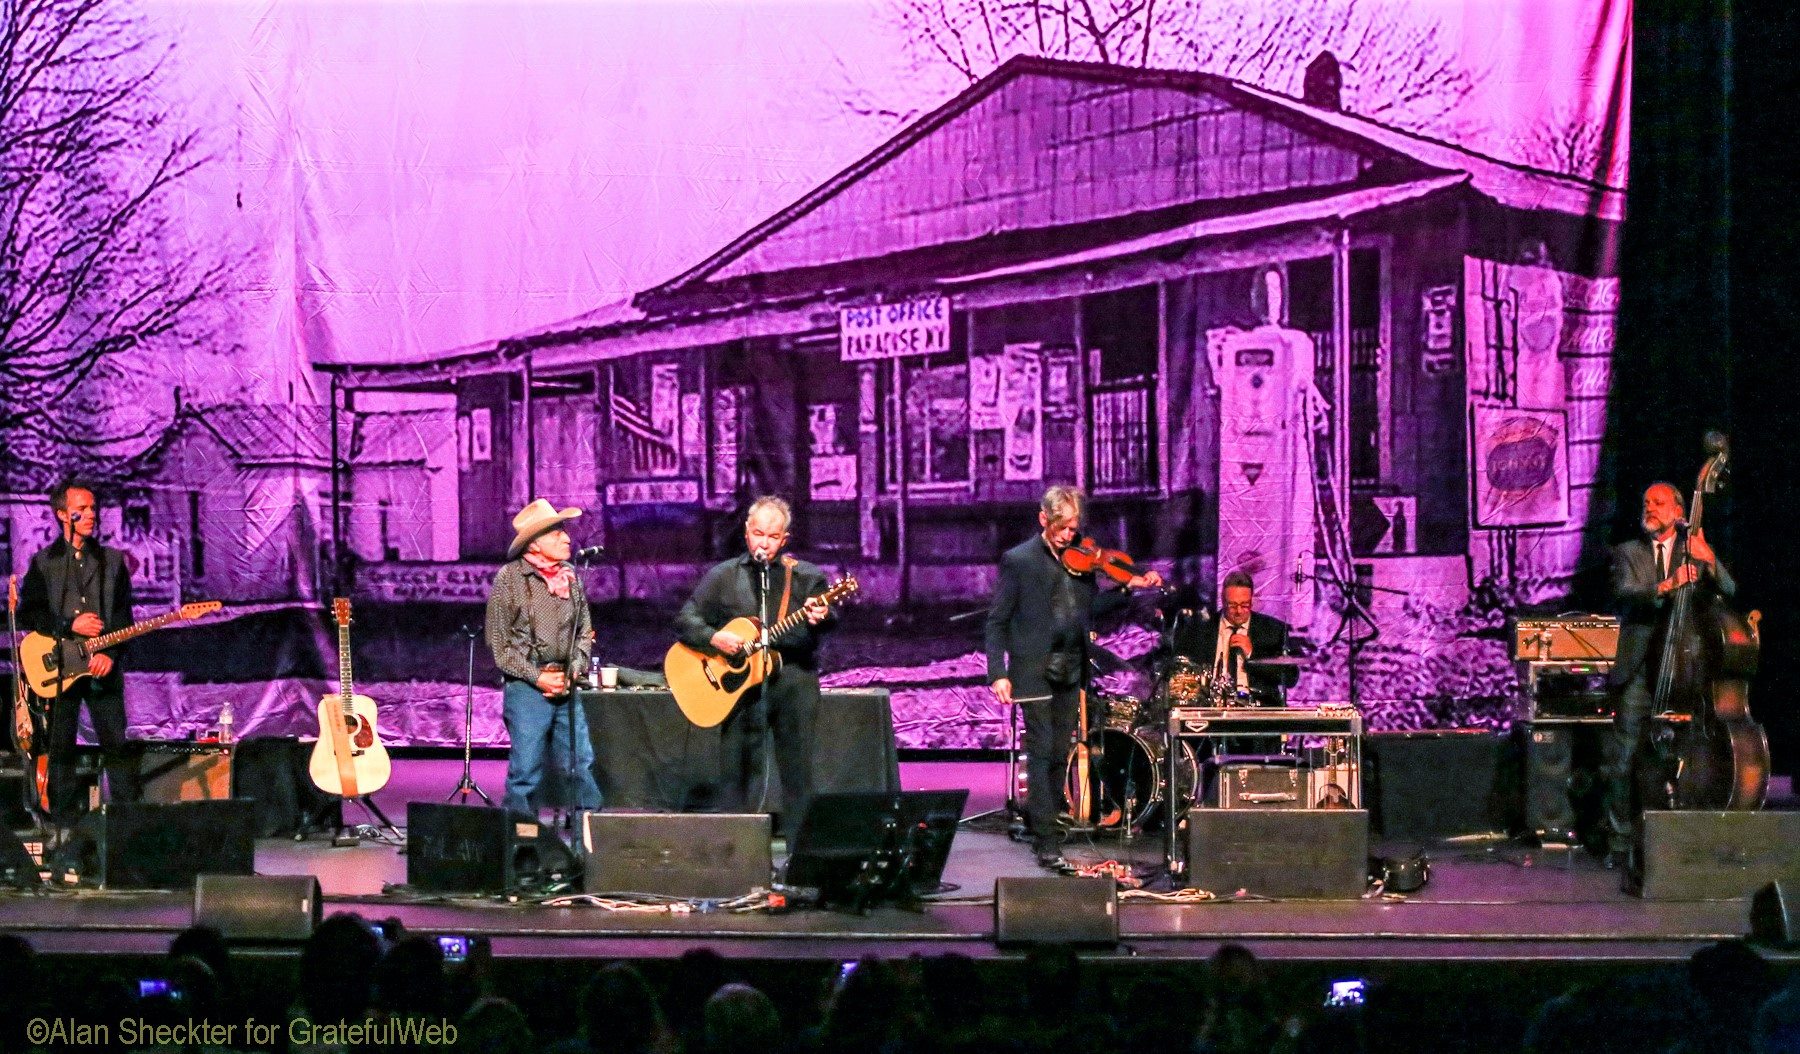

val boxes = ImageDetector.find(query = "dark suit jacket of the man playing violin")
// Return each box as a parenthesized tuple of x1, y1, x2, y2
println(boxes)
(986, 534, 1129, 698)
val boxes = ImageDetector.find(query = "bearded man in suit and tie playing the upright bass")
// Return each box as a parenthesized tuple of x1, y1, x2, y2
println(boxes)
(1604, 482, 1737, 867)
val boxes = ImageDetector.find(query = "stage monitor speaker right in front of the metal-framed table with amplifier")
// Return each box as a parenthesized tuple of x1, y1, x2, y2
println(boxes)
(1188, 809, 1368, 899)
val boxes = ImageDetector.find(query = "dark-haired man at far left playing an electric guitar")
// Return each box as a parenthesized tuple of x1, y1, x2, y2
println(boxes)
(18, 482, 140, 829)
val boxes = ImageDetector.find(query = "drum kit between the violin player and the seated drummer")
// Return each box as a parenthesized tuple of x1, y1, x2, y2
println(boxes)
(1064, 644, 1305, 835)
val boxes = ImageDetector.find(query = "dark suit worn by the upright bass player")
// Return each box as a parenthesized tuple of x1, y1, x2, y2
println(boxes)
(1604, 538, 1737, 853)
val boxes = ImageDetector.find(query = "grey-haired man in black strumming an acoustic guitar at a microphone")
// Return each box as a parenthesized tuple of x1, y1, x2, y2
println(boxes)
(675, 498, 833, 836)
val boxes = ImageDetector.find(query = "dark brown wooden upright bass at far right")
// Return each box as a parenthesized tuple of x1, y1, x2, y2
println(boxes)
(1656, 432, 1769, 811)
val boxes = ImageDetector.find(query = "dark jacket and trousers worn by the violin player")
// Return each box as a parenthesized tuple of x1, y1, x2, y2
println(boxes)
(986, 536, 1127, 851)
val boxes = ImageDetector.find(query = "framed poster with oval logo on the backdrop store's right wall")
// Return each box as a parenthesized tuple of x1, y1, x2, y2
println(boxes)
(1469, 406, 1570, 527)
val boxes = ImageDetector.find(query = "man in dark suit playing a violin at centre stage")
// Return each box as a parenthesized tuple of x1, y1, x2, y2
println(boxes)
(986, 487, 1163, 871)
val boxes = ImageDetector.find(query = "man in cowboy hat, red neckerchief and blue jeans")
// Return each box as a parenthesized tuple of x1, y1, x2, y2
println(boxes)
(488, 498, 599, 817)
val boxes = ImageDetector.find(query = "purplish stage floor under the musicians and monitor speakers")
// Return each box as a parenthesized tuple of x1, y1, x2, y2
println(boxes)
(0, 759, 1791, 964)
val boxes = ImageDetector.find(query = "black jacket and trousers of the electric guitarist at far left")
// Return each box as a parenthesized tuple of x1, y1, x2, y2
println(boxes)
(18, 540, 139, 826)
